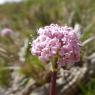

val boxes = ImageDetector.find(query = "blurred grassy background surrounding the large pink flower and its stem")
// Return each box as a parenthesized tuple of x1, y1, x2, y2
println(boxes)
(0, 0, 95, 95)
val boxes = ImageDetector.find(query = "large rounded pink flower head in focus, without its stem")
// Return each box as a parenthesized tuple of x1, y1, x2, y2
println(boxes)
(31, 24, 80, 65)
